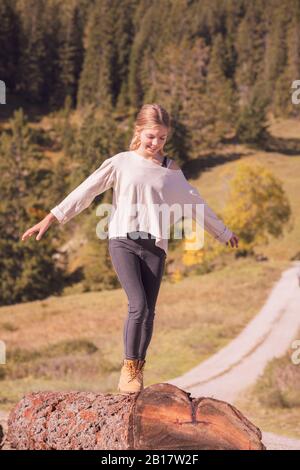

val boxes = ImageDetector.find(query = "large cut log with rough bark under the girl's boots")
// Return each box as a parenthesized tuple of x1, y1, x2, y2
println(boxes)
(7, 383, 265, 450)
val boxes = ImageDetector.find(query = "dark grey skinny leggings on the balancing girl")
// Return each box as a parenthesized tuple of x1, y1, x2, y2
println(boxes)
(108, 231, 166, 359)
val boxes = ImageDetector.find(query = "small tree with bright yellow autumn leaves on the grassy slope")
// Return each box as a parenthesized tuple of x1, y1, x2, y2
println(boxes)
(223, 162, 291, 252)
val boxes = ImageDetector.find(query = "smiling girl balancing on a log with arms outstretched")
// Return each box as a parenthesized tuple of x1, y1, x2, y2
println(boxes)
(22, 104, 238, 393)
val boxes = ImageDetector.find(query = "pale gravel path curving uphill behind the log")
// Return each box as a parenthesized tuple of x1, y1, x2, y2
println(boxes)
(168, 262, 300, 449)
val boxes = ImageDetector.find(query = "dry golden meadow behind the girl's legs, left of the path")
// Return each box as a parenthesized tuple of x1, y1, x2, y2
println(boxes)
(0, 255, 282, 409)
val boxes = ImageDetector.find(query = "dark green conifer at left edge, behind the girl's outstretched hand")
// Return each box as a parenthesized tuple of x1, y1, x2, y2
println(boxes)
(0, 109, 62, 305)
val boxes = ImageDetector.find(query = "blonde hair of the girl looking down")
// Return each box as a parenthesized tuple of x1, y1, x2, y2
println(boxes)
(129, 103, 171, 150)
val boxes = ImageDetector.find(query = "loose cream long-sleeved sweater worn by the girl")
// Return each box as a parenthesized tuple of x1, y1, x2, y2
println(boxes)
(51, 151, 232, 254)
